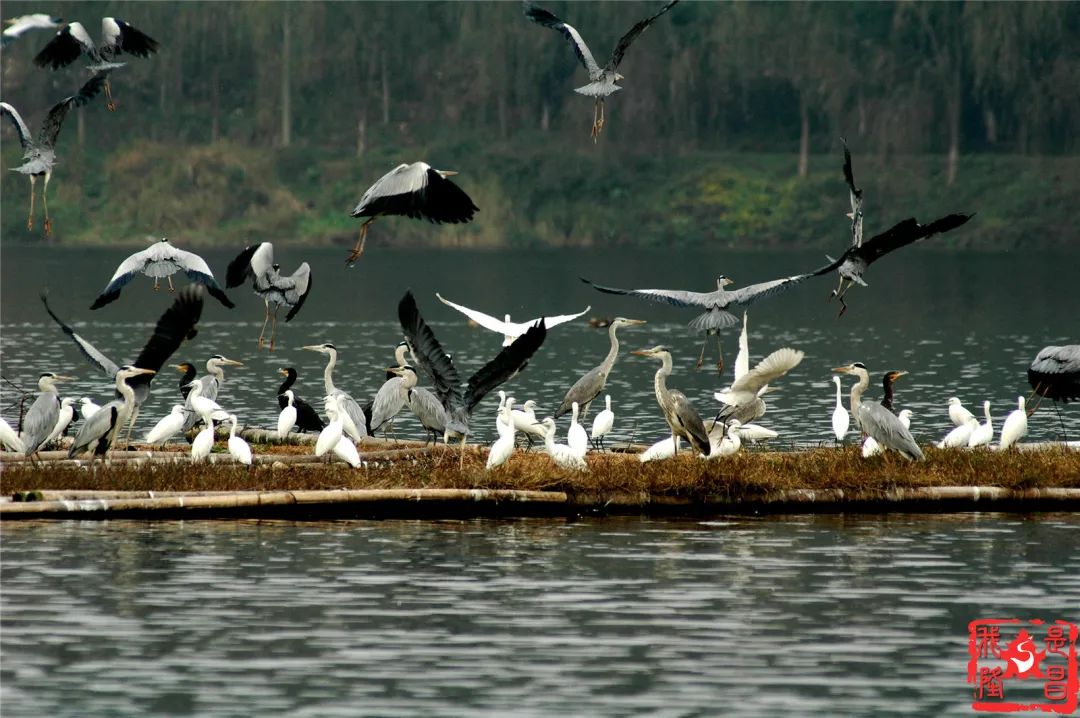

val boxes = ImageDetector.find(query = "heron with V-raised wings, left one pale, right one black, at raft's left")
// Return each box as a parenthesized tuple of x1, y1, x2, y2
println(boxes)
(41, 285, 203, 442)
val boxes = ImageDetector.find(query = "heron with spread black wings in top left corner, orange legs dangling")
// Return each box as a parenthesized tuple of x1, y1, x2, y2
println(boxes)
(33, 17, 158, 110)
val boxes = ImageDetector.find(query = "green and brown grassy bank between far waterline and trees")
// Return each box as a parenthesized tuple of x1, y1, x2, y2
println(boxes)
(0, 134, 1080, 252)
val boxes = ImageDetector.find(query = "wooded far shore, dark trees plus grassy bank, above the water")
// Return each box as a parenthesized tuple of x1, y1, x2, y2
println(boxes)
(0, 0, 1080, 252)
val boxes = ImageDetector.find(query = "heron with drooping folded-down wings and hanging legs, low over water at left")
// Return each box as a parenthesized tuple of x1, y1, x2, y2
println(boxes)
(225, 242, 311, 351)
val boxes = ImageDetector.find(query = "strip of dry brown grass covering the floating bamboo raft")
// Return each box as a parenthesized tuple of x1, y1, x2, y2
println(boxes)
(0, 446, 1080, 499)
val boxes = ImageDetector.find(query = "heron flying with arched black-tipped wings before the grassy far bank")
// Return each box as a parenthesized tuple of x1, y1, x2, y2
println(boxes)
(346, 162, 480, 266)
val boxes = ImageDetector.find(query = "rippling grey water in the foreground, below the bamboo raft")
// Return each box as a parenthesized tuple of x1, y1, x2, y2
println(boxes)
(0, 514, 1080, 717)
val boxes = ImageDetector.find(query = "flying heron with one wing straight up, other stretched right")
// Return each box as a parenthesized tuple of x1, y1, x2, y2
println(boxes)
(813, 143, 974, 316)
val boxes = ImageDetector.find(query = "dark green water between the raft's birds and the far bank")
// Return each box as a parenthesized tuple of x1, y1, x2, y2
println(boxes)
(0, 245, 1080, 449)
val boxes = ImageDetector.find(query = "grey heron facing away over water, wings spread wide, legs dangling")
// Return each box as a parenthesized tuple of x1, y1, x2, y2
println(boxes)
(580, 270, 827, 374)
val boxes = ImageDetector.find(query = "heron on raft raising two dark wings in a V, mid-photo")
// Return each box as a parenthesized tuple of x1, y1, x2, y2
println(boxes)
(397, 292, 548, 462)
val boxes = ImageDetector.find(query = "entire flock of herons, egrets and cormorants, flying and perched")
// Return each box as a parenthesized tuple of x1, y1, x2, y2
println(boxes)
(0, 7, 1080, 472)
